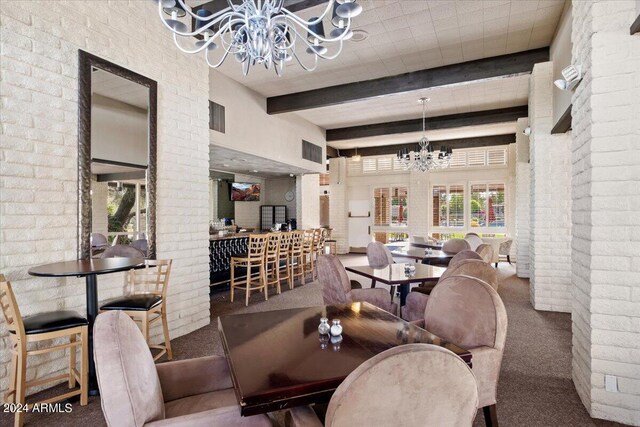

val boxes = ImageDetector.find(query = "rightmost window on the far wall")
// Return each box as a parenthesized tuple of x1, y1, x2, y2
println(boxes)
(469, 184, 505, 231)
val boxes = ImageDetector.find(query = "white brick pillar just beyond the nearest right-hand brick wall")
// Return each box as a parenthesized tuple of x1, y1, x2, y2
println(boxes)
(529, 62, 571, 312)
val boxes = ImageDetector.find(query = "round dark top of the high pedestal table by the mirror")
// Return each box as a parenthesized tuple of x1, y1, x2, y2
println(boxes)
(29, 258, 144, 277)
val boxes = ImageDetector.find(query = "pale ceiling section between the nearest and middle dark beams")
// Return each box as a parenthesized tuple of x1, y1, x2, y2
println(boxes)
(296, 75, 529, 129)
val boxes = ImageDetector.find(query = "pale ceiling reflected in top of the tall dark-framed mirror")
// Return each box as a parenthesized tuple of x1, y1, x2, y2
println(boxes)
(91, 68, 149, 110)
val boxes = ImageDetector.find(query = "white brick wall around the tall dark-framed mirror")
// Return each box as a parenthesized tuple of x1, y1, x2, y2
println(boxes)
(0, 0, 209, 402)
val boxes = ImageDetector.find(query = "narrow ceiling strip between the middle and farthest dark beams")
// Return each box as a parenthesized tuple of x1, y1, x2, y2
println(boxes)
(328, 122, 516, 150)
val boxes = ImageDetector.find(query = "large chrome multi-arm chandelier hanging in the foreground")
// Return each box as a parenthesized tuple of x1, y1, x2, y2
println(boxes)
(156, 0, 362, 76)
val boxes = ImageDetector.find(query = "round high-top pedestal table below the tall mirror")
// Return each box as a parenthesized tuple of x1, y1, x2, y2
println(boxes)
(29, 258, 144, 396)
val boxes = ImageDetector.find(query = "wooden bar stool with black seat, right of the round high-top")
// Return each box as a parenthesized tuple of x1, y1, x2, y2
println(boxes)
(100, 259, 173, 360)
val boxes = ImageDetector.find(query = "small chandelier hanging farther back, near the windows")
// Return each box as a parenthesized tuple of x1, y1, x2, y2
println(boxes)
(398, 98, 453, 172)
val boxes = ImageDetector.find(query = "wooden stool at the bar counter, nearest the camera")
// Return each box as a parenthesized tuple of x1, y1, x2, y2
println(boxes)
(231, 234, 269, 306)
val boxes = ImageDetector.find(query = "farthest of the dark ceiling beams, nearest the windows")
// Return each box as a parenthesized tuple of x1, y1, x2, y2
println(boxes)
(336, 134, 516, 157)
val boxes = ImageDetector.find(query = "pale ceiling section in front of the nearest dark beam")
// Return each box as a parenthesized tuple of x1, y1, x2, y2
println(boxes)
(202, 0, 564, 96)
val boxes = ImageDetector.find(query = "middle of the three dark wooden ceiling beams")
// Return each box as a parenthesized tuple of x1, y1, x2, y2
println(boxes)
(327, 105, 529, 142)
